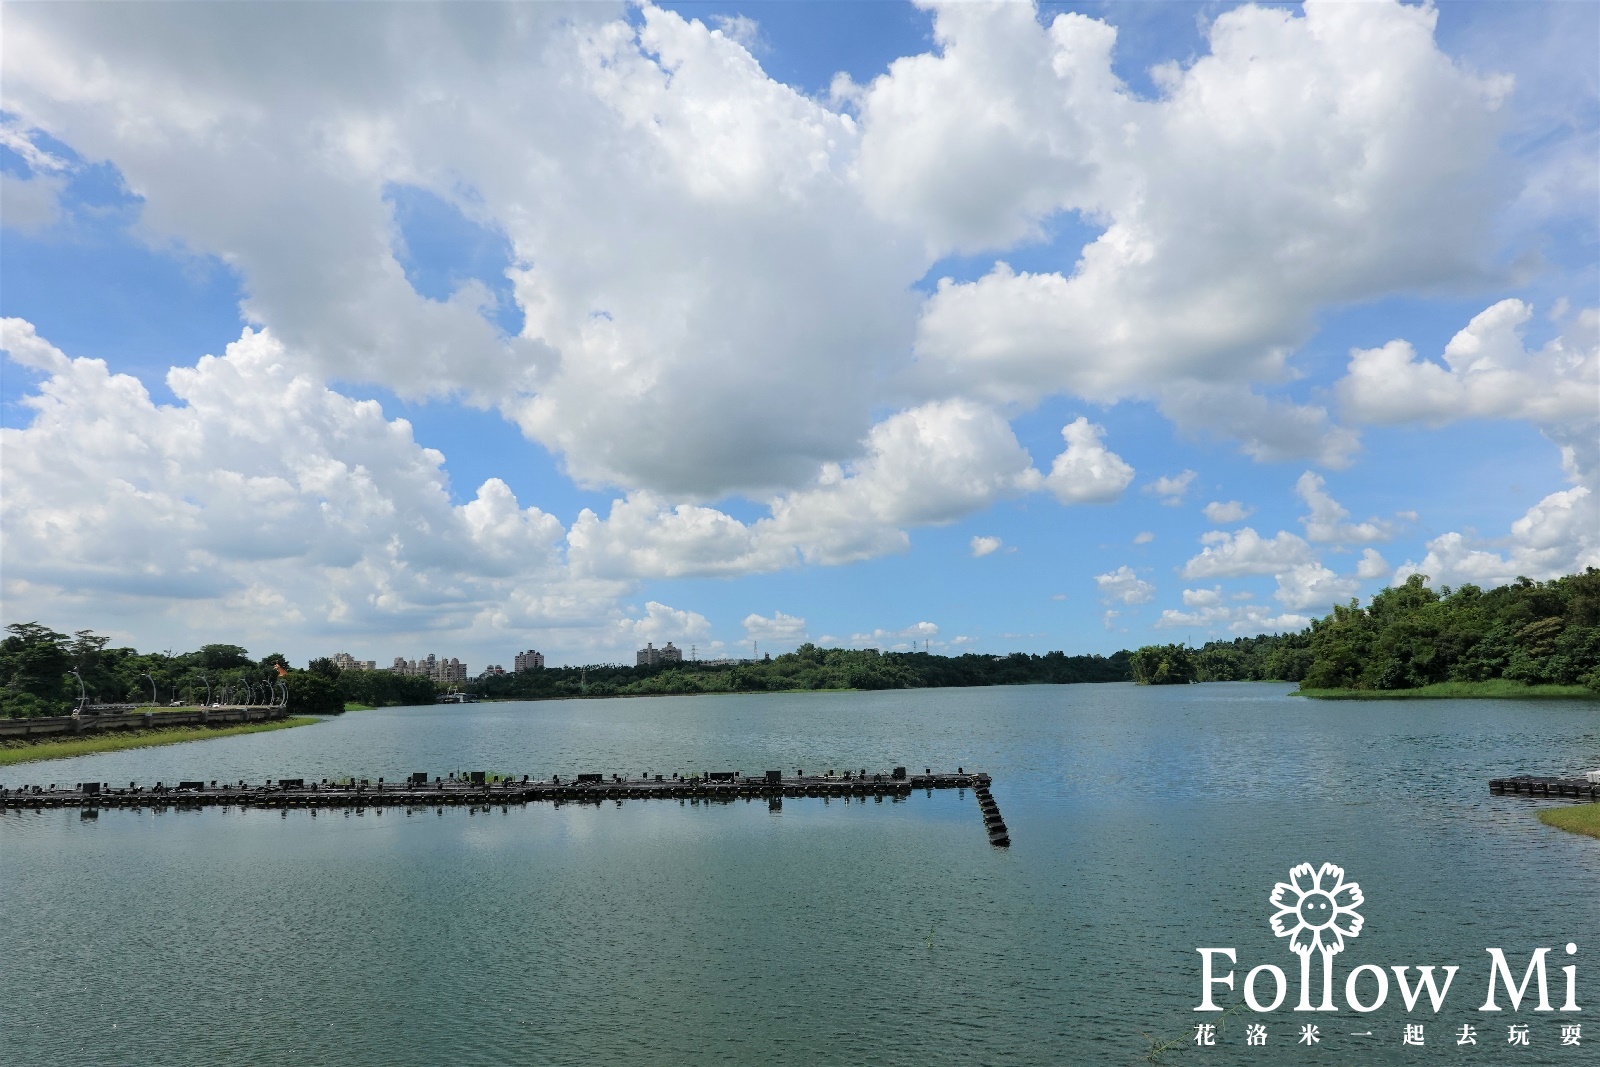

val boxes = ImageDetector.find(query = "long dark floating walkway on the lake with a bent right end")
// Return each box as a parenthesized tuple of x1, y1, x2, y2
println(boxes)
(0, 768, 1011, 846)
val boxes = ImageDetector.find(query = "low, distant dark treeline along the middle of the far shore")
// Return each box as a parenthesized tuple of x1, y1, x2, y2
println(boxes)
(469, 643, 1128, 699)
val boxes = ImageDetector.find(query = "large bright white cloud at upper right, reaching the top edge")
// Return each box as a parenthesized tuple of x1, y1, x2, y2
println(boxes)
(908, 2, 1509, 425)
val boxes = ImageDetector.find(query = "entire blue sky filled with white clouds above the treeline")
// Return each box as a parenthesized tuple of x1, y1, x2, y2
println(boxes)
(0, 3, 1600, 670)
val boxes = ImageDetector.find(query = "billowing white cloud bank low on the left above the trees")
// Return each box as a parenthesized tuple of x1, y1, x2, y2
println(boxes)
(0, 320, 601, 652)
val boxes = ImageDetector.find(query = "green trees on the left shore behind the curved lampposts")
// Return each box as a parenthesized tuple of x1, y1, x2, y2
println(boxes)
(0, 622, 435, 718)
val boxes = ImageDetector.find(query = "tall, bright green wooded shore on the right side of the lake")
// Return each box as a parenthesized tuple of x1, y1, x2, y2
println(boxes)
(1131, 568, 1600, 691)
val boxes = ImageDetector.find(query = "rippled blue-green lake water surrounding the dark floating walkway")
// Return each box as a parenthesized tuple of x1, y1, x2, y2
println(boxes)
(0, 683, 1600, 1067)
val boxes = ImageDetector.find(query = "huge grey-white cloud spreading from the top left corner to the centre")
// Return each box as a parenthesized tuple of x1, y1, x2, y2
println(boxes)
(5, 5, 926, 499)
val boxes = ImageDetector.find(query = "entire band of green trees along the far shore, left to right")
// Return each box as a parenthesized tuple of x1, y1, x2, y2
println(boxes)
(0, 568, 1600, 718)
